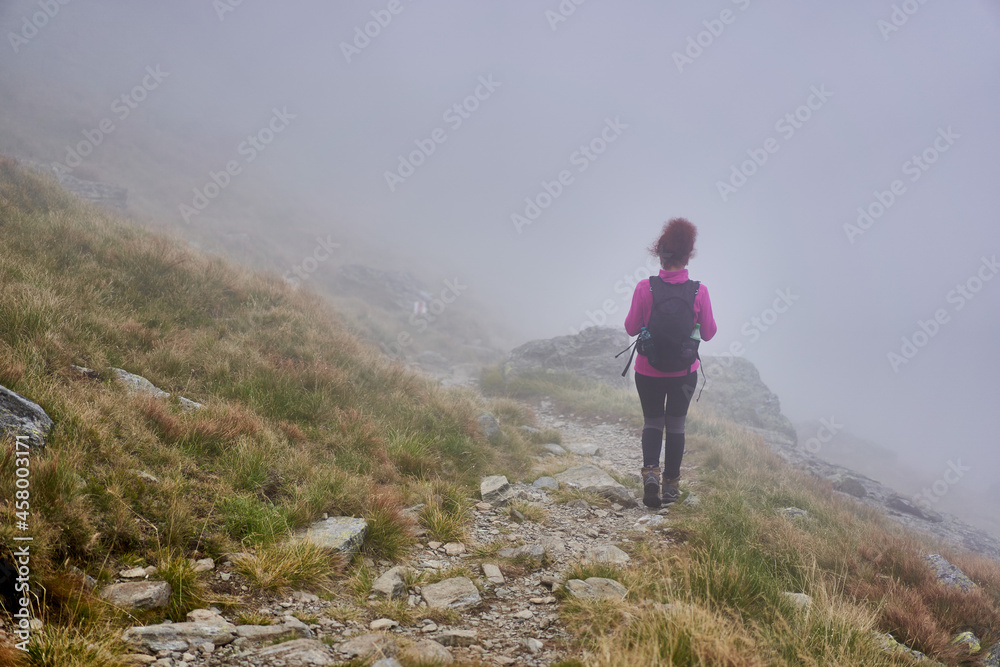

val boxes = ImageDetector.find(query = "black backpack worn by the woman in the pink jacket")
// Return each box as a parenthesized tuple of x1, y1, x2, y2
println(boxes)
(619, 276, 701, 377)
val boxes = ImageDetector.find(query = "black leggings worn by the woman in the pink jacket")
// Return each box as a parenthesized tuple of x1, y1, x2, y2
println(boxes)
(635, 371, 698, 479)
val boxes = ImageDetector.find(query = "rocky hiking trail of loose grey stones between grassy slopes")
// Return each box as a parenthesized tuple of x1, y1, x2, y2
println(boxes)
(113, 402, 684, 667)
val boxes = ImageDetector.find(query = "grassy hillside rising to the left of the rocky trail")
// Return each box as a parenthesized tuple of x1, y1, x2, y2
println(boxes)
(0, 158, 548, 664)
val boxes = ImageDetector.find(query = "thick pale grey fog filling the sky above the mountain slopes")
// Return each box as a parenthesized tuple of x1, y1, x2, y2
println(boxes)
(0, 0, 1000, 498)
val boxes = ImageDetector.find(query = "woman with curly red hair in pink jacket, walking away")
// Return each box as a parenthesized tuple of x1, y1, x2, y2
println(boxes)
(625, 218, 717, 507)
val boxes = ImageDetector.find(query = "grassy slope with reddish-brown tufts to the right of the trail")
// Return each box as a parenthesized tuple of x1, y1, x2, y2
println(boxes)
(483, 371, 1000, 667)
